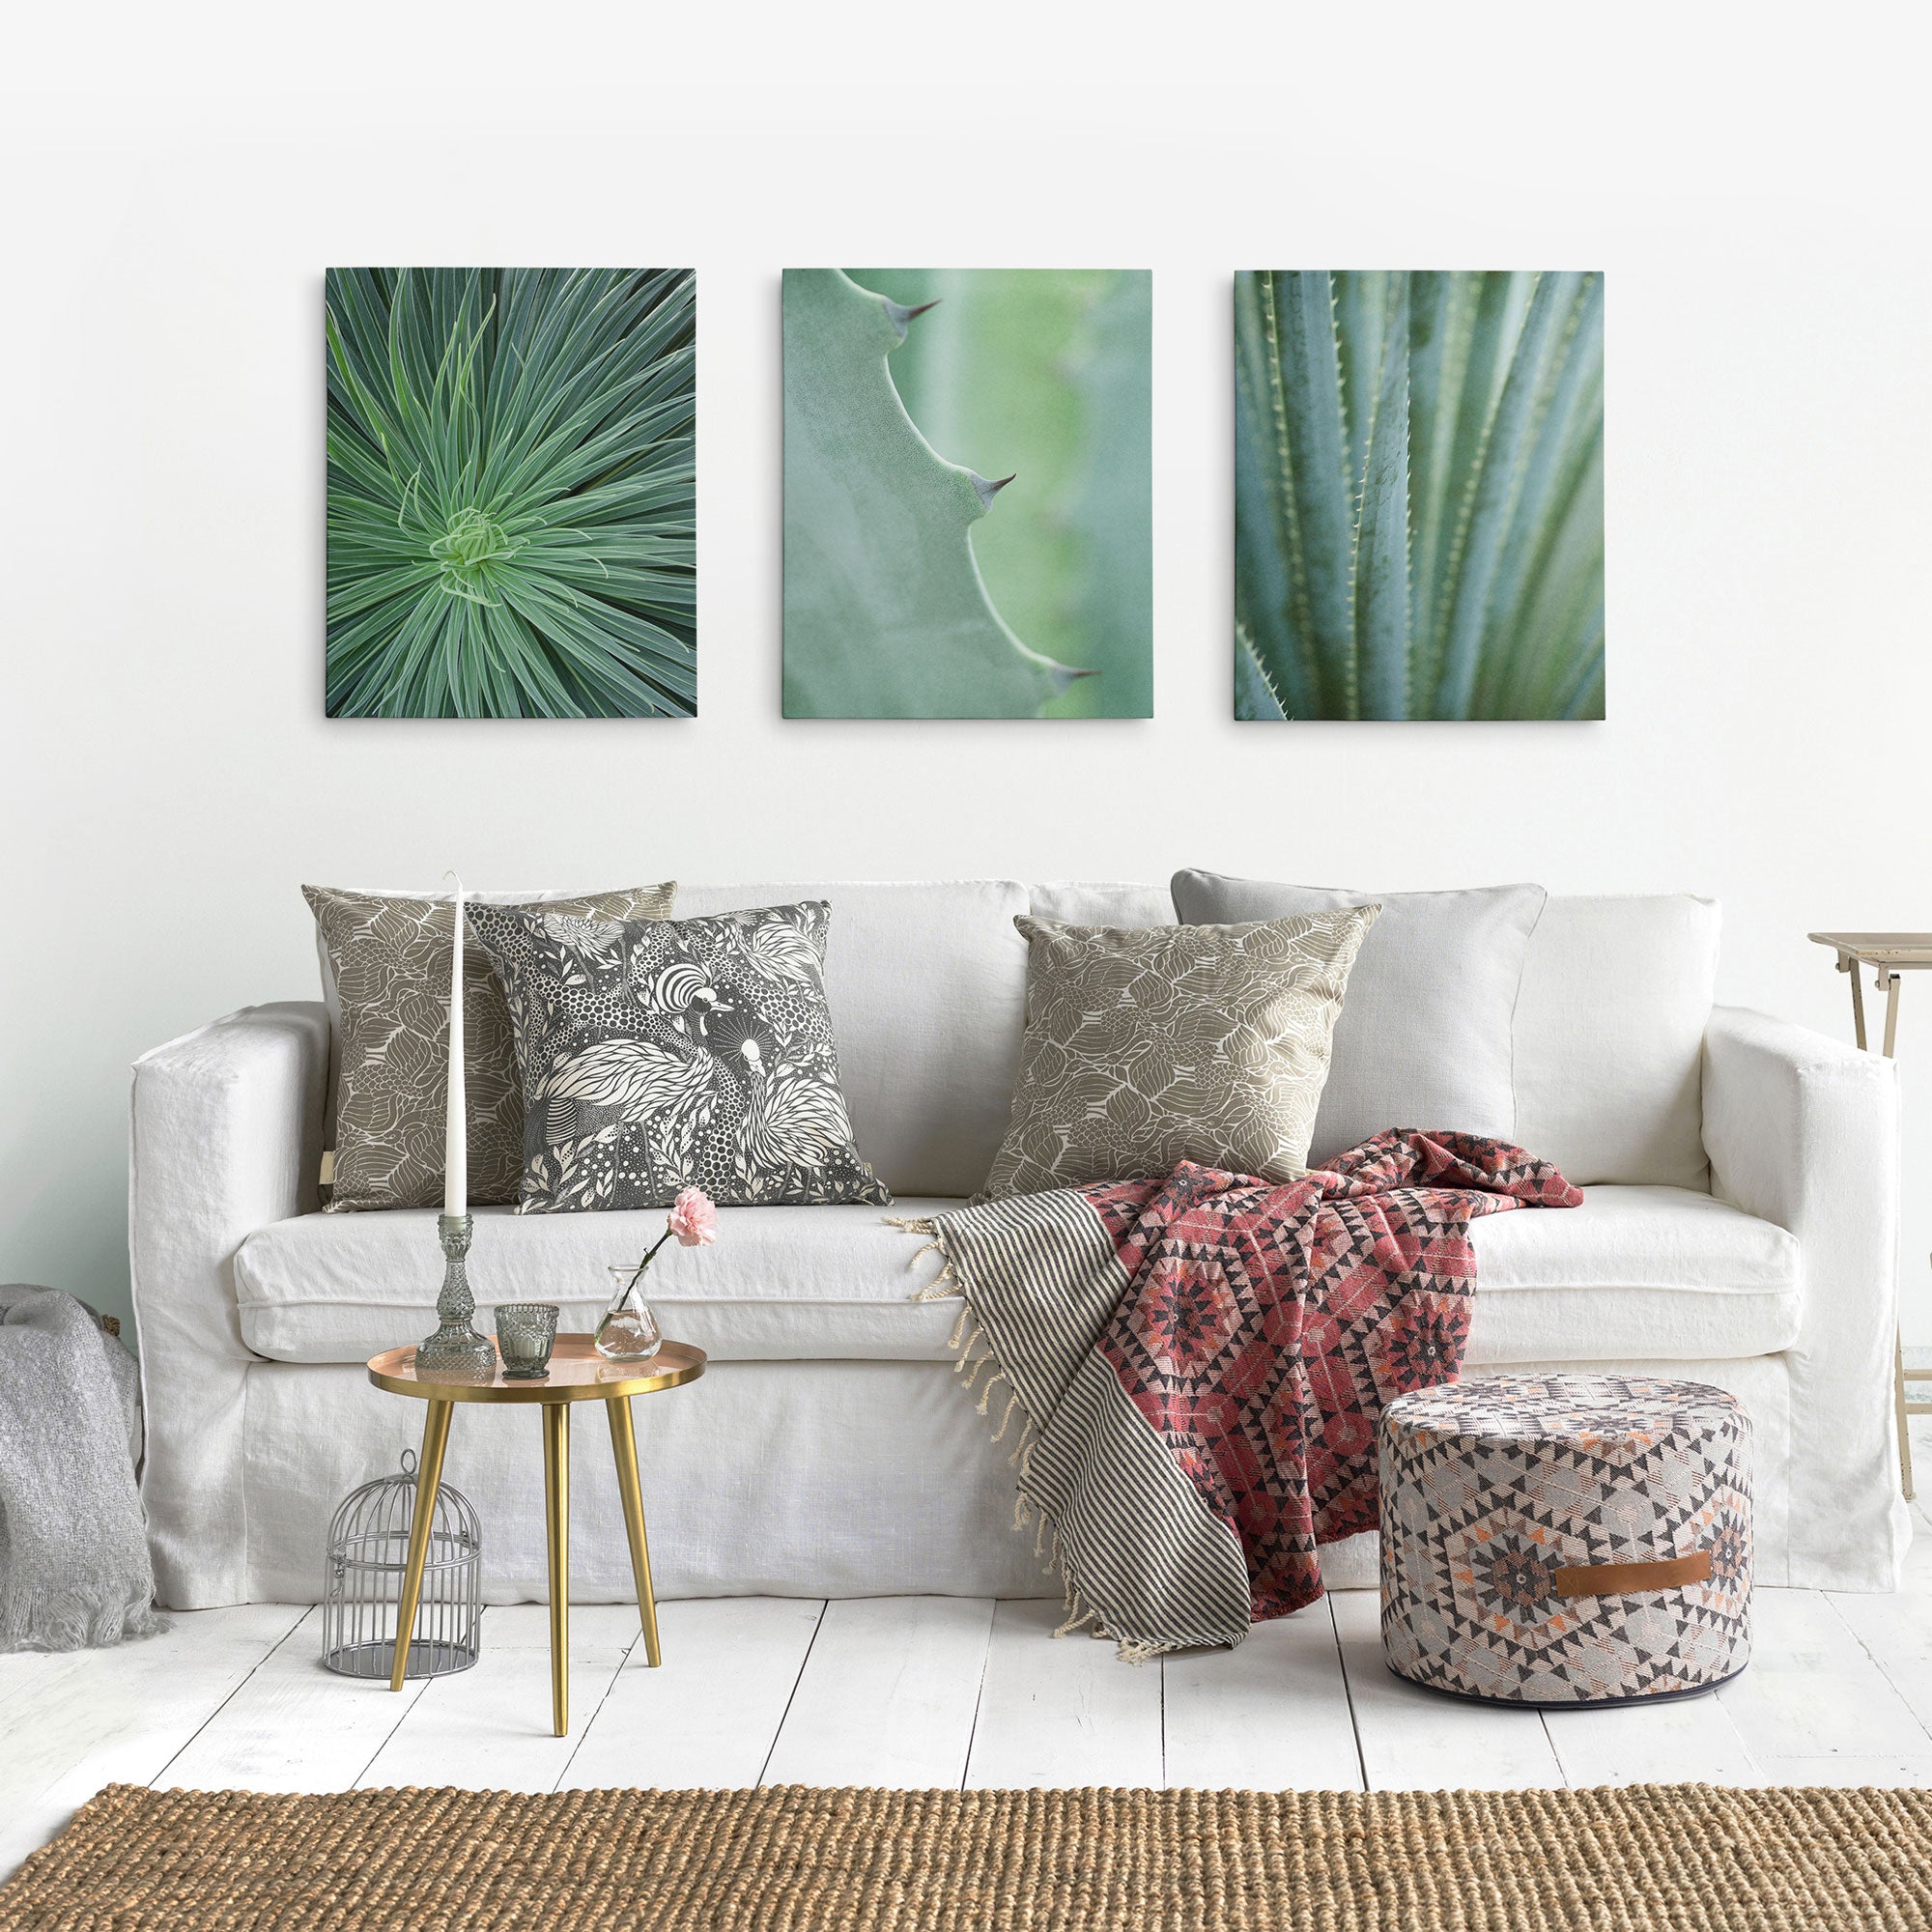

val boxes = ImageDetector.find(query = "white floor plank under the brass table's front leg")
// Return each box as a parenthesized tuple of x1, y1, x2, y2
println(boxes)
(357, 1604, 641, 1791)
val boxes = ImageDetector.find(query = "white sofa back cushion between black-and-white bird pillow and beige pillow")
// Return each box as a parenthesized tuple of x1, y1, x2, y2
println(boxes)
(678, 879, 1028, 1196)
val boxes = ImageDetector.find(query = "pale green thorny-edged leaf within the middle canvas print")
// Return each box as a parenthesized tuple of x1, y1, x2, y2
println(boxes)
(784, 269, 1080, 717)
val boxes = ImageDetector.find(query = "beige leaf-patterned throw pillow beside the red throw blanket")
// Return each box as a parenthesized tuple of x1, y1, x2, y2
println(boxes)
(980, 906, 1381, 1200)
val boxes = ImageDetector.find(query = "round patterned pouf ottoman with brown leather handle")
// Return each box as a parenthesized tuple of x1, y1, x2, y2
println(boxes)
(1381, 1376, 1750, 1706)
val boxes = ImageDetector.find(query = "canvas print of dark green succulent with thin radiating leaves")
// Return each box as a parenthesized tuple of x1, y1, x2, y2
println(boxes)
(327, 269, 697, 719)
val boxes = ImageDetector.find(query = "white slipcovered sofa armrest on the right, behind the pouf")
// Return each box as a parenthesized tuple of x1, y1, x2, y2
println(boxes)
(1704, 1007, 1911, 1590)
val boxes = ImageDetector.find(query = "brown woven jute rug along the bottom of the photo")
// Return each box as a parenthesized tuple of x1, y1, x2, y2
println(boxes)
(0, 1785, 1932, 1932)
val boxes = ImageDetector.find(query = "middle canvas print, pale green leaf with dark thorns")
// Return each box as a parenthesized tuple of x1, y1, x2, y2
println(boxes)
(784, 269, 1153, 719)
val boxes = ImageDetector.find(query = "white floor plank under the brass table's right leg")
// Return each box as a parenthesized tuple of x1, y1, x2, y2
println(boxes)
(562, 1596, 825, 1791)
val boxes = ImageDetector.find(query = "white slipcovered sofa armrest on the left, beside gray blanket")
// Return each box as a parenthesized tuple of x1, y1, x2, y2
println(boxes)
(128, 1001, 328, 1609)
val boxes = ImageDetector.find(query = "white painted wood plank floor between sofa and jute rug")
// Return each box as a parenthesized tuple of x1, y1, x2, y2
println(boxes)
(0, 1453, 1932, 1876)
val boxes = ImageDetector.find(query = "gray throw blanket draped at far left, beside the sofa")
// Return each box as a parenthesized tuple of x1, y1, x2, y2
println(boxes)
(0, 1283, 168, 1650)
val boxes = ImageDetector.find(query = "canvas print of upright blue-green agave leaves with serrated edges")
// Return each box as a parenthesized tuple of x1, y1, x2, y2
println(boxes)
(1235, 269, 1604, 719)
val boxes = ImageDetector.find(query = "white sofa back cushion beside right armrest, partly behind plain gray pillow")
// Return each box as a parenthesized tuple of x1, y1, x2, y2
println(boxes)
(1517, 893, 1719, 1188)
